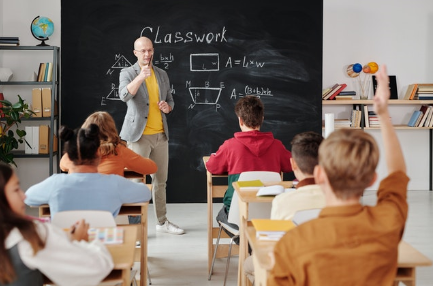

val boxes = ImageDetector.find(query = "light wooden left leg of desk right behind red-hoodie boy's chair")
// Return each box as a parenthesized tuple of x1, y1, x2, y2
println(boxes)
(238, 200, 248, 286)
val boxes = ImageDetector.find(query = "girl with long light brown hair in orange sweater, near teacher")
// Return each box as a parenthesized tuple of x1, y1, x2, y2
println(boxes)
(60, 111, 158, 176)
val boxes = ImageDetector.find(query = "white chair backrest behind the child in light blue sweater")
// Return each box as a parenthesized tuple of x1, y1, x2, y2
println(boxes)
(51, 210, 116, 228)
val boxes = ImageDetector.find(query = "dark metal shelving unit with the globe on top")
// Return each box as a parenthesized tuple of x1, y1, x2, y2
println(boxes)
(0, 46, 60, 176)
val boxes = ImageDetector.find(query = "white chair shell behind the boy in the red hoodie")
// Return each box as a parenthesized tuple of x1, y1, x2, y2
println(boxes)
(227, 171, 281, 225)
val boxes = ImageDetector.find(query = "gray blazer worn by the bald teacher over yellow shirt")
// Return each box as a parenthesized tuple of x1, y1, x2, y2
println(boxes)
(119, 62, 174, 142)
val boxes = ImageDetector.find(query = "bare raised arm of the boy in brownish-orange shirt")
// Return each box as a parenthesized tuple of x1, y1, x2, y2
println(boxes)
(374, 65, 406, 174)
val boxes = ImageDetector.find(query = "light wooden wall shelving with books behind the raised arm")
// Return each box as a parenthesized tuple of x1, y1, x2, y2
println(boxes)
(322, 99, 433, 191)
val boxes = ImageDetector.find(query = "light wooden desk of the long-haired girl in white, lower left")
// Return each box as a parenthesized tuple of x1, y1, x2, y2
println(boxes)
(44, 225, 137, 286)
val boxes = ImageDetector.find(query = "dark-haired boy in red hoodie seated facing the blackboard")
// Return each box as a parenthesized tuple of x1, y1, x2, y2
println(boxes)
(206, 95, 292, 238)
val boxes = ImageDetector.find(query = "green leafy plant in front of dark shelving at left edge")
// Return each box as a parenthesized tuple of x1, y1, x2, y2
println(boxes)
(0, 95, 34, 166)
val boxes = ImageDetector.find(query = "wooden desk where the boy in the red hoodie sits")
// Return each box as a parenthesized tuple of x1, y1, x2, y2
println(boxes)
(203, 156, 239, 273)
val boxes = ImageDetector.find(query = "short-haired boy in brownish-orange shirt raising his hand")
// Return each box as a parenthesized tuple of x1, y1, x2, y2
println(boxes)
(267, 66, 409, 286)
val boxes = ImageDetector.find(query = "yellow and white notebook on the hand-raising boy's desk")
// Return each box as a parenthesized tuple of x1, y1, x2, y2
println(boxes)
(251, 219, 296, 240)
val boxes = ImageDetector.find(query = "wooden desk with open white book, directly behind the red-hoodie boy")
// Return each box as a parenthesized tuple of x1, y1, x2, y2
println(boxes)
(233, 181, 293, 286)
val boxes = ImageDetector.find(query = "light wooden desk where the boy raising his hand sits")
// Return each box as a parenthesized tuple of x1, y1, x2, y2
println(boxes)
(246, 225, 432, 286)
